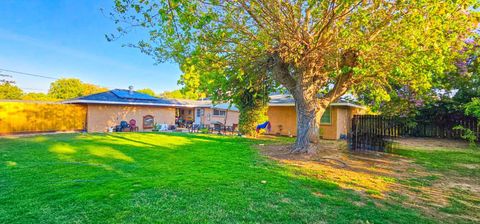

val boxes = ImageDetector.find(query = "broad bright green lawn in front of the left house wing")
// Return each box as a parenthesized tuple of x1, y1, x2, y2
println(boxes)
(0, 133, 435, 223)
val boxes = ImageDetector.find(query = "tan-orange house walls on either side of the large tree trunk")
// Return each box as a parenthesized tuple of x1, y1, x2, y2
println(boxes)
(267, 106, 362, 139)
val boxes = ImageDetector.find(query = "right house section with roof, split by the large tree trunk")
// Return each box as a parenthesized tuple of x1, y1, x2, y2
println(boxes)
(267, 95, 365, 139)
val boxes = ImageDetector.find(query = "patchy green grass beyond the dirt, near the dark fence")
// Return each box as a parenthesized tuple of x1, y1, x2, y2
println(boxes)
(393, 147, 480, 223)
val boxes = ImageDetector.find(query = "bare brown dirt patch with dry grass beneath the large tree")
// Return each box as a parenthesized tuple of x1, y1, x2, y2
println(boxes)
(258, 139, 480, 221)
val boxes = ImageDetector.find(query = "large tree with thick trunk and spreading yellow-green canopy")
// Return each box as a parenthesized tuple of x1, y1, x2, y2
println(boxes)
(108, 0, 478, 152)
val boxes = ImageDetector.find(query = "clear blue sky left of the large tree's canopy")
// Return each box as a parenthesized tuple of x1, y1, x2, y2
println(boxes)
(0, 0, 181, 92)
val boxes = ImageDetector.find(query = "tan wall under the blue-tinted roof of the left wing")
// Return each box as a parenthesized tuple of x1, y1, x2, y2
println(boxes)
(87, 104, 175, 132)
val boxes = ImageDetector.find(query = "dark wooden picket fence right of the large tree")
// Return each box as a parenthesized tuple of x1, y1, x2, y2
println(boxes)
(348, 115, 480, 151)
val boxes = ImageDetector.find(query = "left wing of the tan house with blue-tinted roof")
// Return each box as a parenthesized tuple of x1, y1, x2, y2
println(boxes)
(63, 89, 239, 132)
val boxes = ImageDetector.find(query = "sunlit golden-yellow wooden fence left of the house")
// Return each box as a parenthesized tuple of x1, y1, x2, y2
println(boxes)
(0, 101, 87, 135)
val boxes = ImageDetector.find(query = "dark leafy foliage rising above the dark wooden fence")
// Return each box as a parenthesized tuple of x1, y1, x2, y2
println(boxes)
(374, 39, 480, 117)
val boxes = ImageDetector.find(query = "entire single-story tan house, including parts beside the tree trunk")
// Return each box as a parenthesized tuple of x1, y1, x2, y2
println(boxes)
(63, 89, 365, 139)
